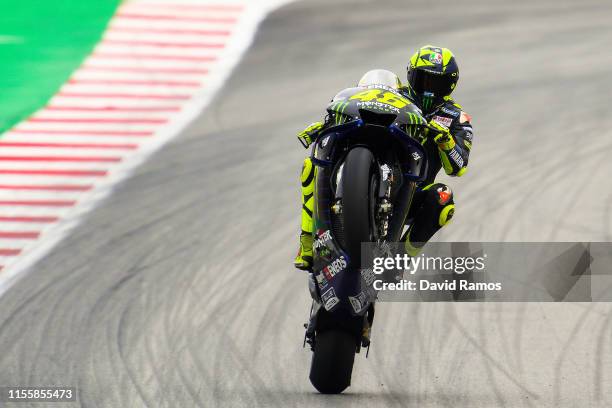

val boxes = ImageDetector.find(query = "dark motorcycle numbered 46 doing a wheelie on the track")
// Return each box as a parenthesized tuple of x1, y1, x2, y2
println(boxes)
(304, 85, 428, 394)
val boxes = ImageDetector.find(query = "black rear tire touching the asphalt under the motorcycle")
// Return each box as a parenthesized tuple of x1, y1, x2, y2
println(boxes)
(310, 329, 357, 394)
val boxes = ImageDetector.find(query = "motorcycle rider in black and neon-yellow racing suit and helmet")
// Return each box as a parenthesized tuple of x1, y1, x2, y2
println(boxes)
(294, 45, 473, 269)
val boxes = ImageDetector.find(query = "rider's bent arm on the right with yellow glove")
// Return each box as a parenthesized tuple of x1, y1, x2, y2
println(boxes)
(430, 112, 473, 177)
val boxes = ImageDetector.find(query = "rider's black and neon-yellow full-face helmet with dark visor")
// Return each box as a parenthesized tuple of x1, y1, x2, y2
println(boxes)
(408, 45, 459, 110)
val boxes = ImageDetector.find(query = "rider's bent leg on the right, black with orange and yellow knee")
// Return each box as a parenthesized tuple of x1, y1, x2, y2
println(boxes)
(405, 183, 455, 256)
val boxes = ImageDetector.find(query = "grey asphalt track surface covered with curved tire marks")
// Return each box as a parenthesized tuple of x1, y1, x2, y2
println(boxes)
(0, 0, 612, 407)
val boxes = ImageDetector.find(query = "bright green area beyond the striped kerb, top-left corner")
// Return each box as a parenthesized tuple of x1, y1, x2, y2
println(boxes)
(0, 0, 119, 132)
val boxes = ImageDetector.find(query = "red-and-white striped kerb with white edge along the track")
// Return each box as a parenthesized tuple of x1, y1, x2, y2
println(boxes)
(0, 0, 290, 295)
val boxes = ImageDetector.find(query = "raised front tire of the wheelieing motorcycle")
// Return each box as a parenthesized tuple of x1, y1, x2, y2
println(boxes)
(341, 147, 376, 268)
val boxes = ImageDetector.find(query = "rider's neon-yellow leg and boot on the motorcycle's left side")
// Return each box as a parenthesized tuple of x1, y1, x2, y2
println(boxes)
(293, 157, 315, 269)
